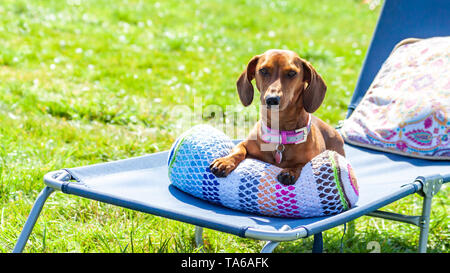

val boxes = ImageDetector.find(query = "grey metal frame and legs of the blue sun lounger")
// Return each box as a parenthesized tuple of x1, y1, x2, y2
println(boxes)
(13, 170, 450, 253)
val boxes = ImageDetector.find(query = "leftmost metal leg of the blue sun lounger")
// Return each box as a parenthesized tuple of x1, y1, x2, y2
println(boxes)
(13, 187, 54, 253)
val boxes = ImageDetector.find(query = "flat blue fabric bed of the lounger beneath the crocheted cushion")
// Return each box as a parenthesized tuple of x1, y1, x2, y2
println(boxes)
(65, 142, 450, 236)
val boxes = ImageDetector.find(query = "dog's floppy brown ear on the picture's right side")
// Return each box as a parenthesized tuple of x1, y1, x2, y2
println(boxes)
(302, 59, 327, 113)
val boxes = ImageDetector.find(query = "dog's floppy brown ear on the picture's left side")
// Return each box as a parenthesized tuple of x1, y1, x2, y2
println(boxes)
(236, 56, 260, 106)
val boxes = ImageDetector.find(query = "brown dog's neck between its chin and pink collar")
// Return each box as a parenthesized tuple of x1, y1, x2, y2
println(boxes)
(261, 107, 309, 131)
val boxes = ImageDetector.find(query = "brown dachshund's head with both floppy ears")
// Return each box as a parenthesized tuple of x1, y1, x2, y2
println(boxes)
(236, 50, 327, 113)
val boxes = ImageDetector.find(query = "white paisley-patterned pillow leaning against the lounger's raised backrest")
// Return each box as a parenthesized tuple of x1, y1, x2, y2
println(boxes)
(341, 37, 450, 160)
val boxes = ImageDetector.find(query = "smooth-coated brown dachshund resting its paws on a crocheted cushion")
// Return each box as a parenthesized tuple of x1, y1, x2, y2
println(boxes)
(210, 50, 345, 185)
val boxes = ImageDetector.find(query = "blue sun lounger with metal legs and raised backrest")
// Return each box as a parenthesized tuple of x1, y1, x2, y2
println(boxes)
(13, 0, 450, 252)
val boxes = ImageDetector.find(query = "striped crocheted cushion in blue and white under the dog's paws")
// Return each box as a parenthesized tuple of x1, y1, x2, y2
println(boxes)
(168, 125, 358, 218)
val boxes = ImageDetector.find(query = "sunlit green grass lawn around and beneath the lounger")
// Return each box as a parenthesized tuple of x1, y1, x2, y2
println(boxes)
(0, 0, 449, 252)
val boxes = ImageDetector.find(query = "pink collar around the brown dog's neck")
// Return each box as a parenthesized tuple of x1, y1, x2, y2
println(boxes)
(261, 114, 311, 144)
